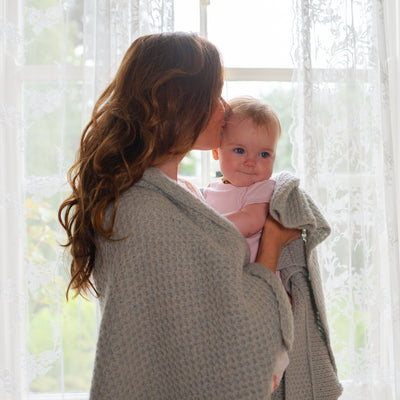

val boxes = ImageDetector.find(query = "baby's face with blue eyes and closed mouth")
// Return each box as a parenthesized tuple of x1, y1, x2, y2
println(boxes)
(213, 116, 278, 186)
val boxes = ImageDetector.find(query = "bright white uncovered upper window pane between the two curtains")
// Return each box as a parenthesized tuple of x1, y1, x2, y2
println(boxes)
(208, 0, 293, 68)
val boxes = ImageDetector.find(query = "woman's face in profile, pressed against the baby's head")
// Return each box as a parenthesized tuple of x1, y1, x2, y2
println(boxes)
(193, 97, 229, 150)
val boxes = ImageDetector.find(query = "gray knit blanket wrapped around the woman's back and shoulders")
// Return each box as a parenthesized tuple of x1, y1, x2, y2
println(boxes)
(90, 168, 293, 400)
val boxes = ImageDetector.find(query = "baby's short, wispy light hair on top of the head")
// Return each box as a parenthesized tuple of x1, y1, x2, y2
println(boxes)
(229, 96, 282, 137)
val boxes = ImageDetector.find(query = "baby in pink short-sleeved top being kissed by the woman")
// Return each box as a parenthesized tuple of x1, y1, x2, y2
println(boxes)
(204, 97, 289, 393)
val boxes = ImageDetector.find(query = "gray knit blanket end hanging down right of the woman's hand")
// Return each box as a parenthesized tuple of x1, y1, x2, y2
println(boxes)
(270, 172, 342, 400)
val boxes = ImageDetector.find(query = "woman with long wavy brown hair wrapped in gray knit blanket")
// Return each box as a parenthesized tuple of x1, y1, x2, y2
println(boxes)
(59, 33, 299, 400)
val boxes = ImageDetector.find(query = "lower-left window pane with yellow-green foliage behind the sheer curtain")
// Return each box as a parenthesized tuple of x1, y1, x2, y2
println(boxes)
(25, 191, 96, 393)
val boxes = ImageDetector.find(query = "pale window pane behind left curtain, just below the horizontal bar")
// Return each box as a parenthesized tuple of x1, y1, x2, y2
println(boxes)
(24, 82, 82, 176)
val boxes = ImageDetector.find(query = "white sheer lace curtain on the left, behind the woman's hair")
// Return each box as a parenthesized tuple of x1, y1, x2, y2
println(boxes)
(0, 0, 173, 400)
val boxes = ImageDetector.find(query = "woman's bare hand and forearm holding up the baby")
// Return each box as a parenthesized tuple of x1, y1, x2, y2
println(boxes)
(256, 215, 301, 272)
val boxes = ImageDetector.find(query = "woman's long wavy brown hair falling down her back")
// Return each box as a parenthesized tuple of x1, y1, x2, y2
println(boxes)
(58, 33, 223, 299)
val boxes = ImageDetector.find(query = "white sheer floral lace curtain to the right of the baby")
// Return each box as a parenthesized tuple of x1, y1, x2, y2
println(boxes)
(291, 0, 400, 400)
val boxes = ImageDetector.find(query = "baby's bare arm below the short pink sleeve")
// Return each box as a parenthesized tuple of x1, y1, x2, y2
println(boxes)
(224, 203, 269, 237)
